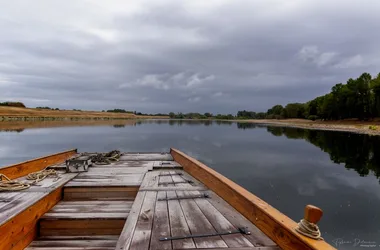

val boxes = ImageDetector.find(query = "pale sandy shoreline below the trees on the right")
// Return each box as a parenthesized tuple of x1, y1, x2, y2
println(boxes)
(234, 119, 380, 135)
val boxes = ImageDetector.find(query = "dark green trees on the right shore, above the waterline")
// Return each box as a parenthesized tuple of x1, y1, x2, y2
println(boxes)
(237, 73, 380, 120)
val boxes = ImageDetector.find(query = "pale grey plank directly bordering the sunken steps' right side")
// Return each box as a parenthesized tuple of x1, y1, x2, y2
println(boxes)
(116, 192, 146, 250)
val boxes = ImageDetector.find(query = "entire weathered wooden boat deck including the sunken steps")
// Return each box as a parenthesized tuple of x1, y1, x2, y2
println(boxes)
(0, 150, 333, 250)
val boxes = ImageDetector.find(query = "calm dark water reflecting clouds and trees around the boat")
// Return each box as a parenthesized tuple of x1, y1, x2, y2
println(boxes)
(0, 121, 380, 249)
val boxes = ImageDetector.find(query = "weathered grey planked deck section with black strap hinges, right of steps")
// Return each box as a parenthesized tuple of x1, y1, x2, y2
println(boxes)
(117, 169, 278, 250)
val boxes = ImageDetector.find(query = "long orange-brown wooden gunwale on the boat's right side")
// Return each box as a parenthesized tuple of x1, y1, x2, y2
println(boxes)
(170, 149, 335, 250)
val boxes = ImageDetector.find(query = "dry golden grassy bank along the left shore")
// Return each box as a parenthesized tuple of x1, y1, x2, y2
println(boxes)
(0, 106, 169, 121)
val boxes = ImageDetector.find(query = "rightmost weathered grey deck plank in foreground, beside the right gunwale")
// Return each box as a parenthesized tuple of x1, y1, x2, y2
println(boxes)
(208, 191, 276, 246)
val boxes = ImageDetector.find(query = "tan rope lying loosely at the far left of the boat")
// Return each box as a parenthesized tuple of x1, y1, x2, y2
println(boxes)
(0, 168, 59, 192)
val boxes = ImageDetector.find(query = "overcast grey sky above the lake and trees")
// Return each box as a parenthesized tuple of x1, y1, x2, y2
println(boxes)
(0, 0, 380, 113)
